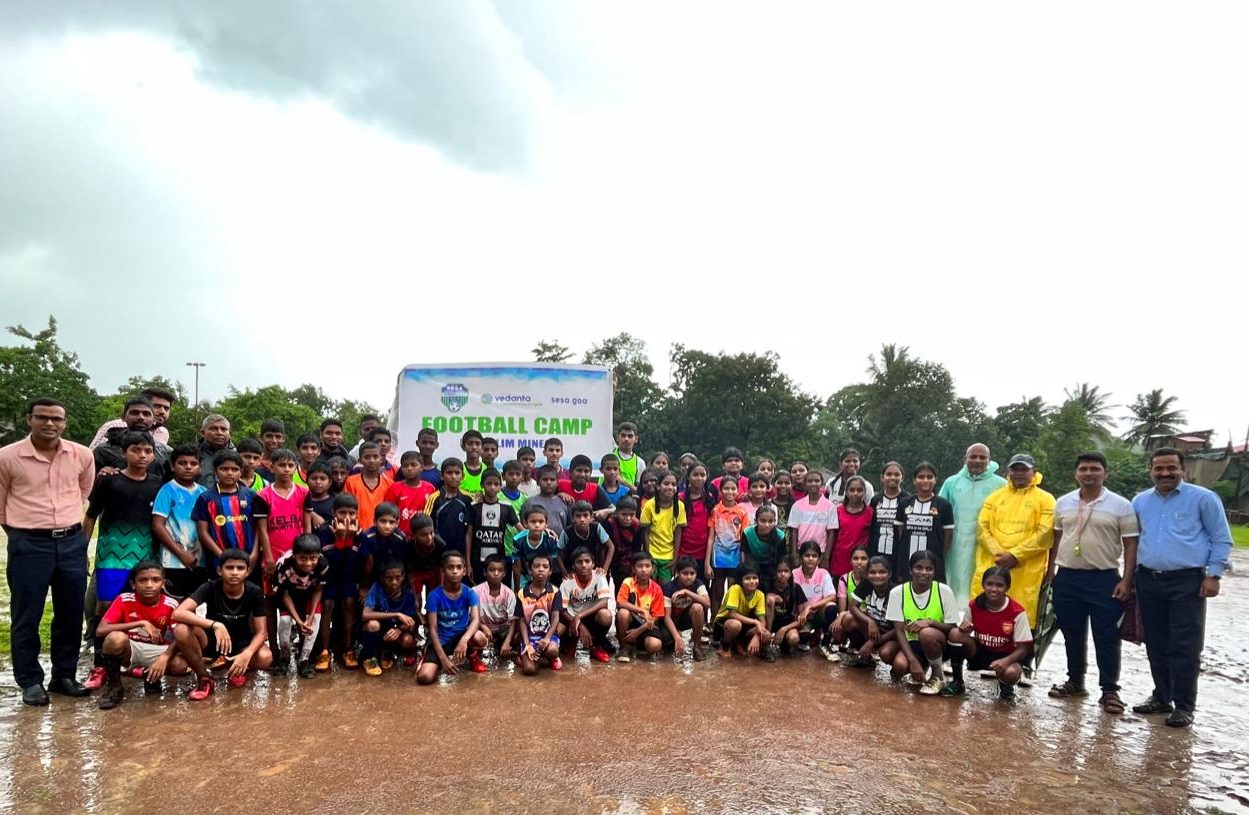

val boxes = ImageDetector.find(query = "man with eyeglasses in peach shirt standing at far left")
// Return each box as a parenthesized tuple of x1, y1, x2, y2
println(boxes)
(0, 398, 95, 705)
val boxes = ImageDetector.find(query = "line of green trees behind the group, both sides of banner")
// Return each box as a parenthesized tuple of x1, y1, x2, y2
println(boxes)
(0, 318, 1184, 495)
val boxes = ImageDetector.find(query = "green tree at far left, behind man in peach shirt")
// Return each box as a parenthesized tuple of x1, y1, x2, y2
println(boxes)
(0, 317, 98, 444)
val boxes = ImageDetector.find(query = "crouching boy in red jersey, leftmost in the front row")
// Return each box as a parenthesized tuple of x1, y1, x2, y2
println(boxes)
(96, 560, 186, 710)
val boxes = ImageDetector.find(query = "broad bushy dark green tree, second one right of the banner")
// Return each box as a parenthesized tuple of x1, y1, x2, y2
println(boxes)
(643, 343, 816, 463)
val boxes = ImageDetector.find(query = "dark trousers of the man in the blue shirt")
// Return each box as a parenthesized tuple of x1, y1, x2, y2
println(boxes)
(1135, 568, 1205, 713)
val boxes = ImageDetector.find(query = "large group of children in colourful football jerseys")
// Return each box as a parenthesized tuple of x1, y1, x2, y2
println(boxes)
(85, 422, 1032, 708)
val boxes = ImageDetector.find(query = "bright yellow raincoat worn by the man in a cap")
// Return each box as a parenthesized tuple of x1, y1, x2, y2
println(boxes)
(972, 473, 1055, 629)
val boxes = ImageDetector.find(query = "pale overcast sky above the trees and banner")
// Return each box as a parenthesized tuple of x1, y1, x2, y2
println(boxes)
(0, 0, 1249, 441)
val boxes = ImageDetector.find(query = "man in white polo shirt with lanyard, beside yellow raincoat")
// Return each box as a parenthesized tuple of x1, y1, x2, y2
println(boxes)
(1049, 453, 1140, 714)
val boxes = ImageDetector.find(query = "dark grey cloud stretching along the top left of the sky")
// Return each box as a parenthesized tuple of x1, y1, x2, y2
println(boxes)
(0, 0, 619, 172)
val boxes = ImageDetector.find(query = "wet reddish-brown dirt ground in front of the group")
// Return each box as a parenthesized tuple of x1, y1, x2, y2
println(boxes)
(0, 552, 1249, 815)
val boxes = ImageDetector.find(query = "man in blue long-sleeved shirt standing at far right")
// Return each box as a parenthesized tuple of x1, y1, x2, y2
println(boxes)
(1132, 447, 1232, 728)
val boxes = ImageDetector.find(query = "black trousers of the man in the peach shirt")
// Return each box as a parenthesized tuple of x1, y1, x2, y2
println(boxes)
(5, 529, 87, 688)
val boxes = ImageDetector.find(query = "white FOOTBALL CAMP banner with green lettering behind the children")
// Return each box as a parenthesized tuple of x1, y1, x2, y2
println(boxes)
(388, 362, 616, 469)
